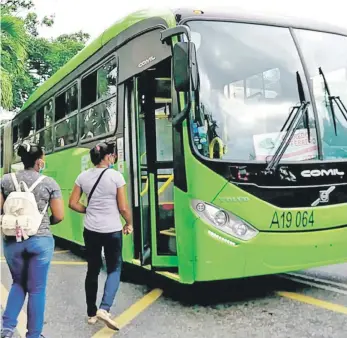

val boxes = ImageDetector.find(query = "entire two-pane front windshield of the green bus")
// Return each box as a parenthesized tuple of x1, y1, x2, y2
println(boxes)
(188, 21, 347, 162)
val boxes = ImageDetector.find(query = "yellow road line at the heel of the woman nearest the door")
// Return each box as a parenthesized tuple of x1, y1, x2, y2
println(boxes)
(92, 289, 163, 338)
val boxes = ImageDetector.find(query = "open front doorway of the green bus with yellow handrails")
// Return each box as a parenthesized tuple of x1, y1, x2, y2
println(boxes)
(128, 58, 177, 268)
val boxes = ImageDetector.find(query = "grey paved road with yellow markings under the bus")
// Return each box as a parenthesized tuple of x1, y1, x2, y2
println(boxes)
(1, 248, 347, 338)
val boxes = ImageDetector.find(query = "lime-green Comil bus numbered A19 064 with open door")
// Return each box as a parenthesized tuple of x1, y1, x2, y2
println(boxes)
(4, 9, 347, 284)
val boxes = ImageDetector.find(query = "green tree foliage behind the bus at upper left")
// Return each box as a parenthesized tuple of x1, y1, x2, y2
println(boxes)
(1, 0, 90, 110)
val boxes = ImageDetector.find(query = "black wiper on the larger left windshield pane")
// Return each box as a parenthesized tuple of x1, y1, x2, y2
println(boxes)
(265, 72, 310, 172)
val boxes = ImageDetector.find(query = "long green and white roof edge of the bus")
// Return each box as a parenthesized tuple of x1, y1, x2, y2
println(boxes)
(21, 9, 347, 112)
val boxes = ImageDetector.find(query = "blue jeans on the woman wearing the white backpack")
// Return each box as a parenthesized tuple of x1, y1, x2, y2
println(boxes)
(2, 236, 54, 338)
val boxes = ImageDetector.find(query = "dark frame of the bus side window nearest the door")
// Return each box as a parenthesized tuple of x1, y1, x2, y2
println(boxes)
(78, 51, 120, 144)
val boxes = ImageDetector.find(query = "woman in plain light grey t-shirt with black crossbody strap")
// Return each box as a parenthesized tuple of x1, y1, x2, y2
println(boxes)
(69, 143, 133, 330)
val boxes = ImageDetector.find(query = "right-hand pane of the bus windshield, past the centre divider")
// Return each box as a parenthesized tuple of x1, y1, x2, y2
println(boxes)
(295, 30, 347, 159)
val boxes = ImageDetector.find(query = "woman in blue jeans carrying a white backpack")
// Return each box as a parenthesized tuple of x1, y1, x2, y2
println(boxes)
(0, 142, 64, 338)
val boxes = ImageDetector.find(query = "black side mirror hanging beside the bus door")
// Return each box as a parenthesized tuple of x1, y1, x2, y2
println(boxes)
(173, 42, 198, 92)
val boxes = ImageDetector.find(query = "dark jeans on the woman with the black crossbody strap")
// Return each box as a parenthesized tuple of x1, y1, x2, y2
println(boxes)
(83, 228, 123, 317)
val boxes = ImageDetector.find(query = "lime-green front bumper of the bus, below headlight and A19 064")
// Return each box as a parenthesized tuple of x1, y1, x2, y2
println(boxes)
(195, 220, 347, 281)
